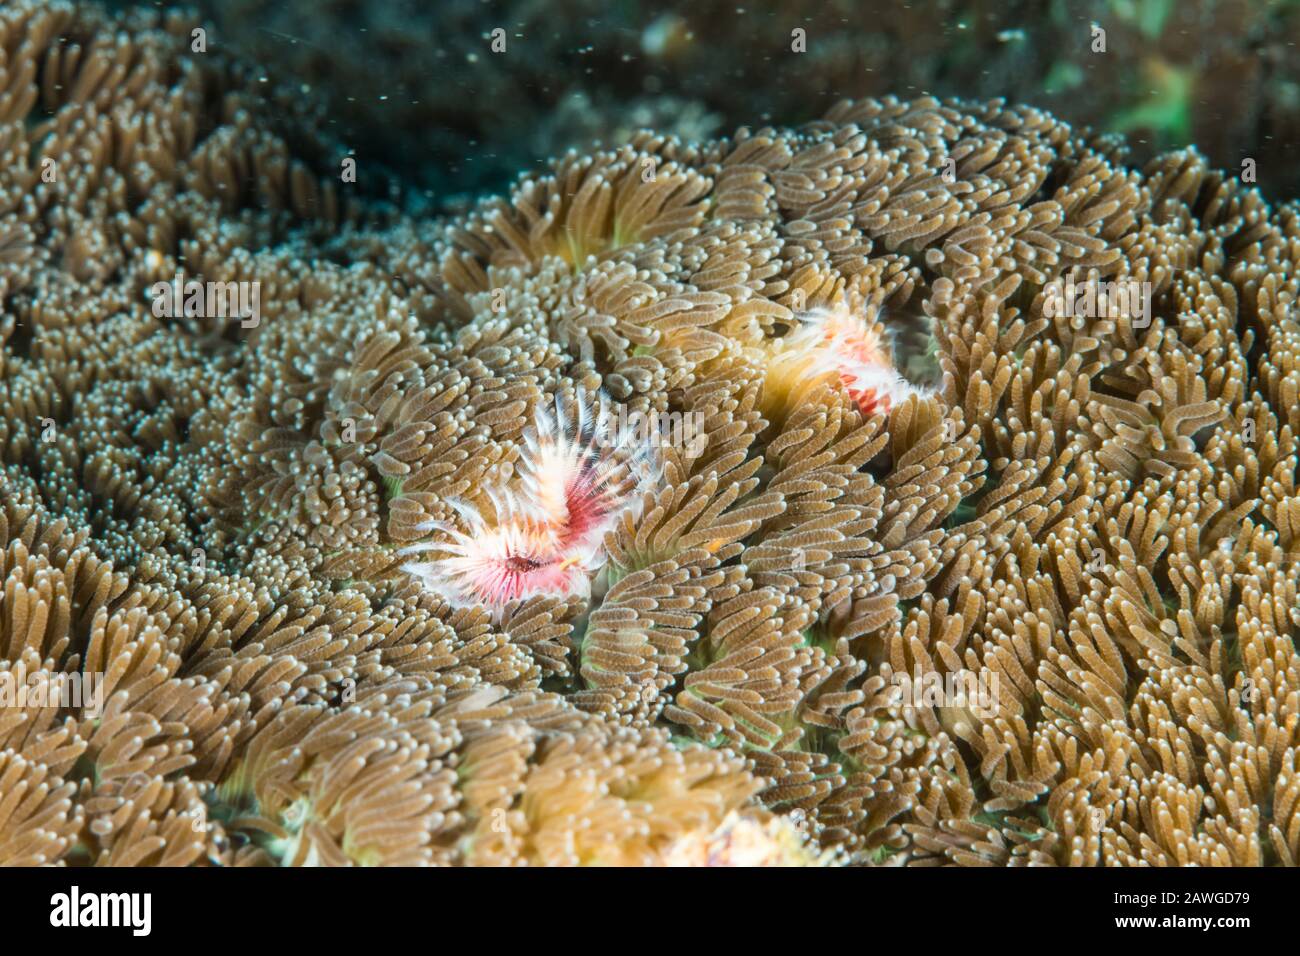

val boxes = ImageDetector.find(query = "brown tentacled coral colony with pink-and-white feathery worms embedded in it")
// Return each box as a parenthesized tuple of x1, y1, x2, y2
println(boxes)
(0, 0, 1300, 866)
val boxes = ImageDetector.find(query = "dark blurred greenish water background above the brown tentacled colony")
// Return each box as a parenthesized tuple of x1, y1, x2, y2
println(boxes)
(116, 0, 1300, 207)
